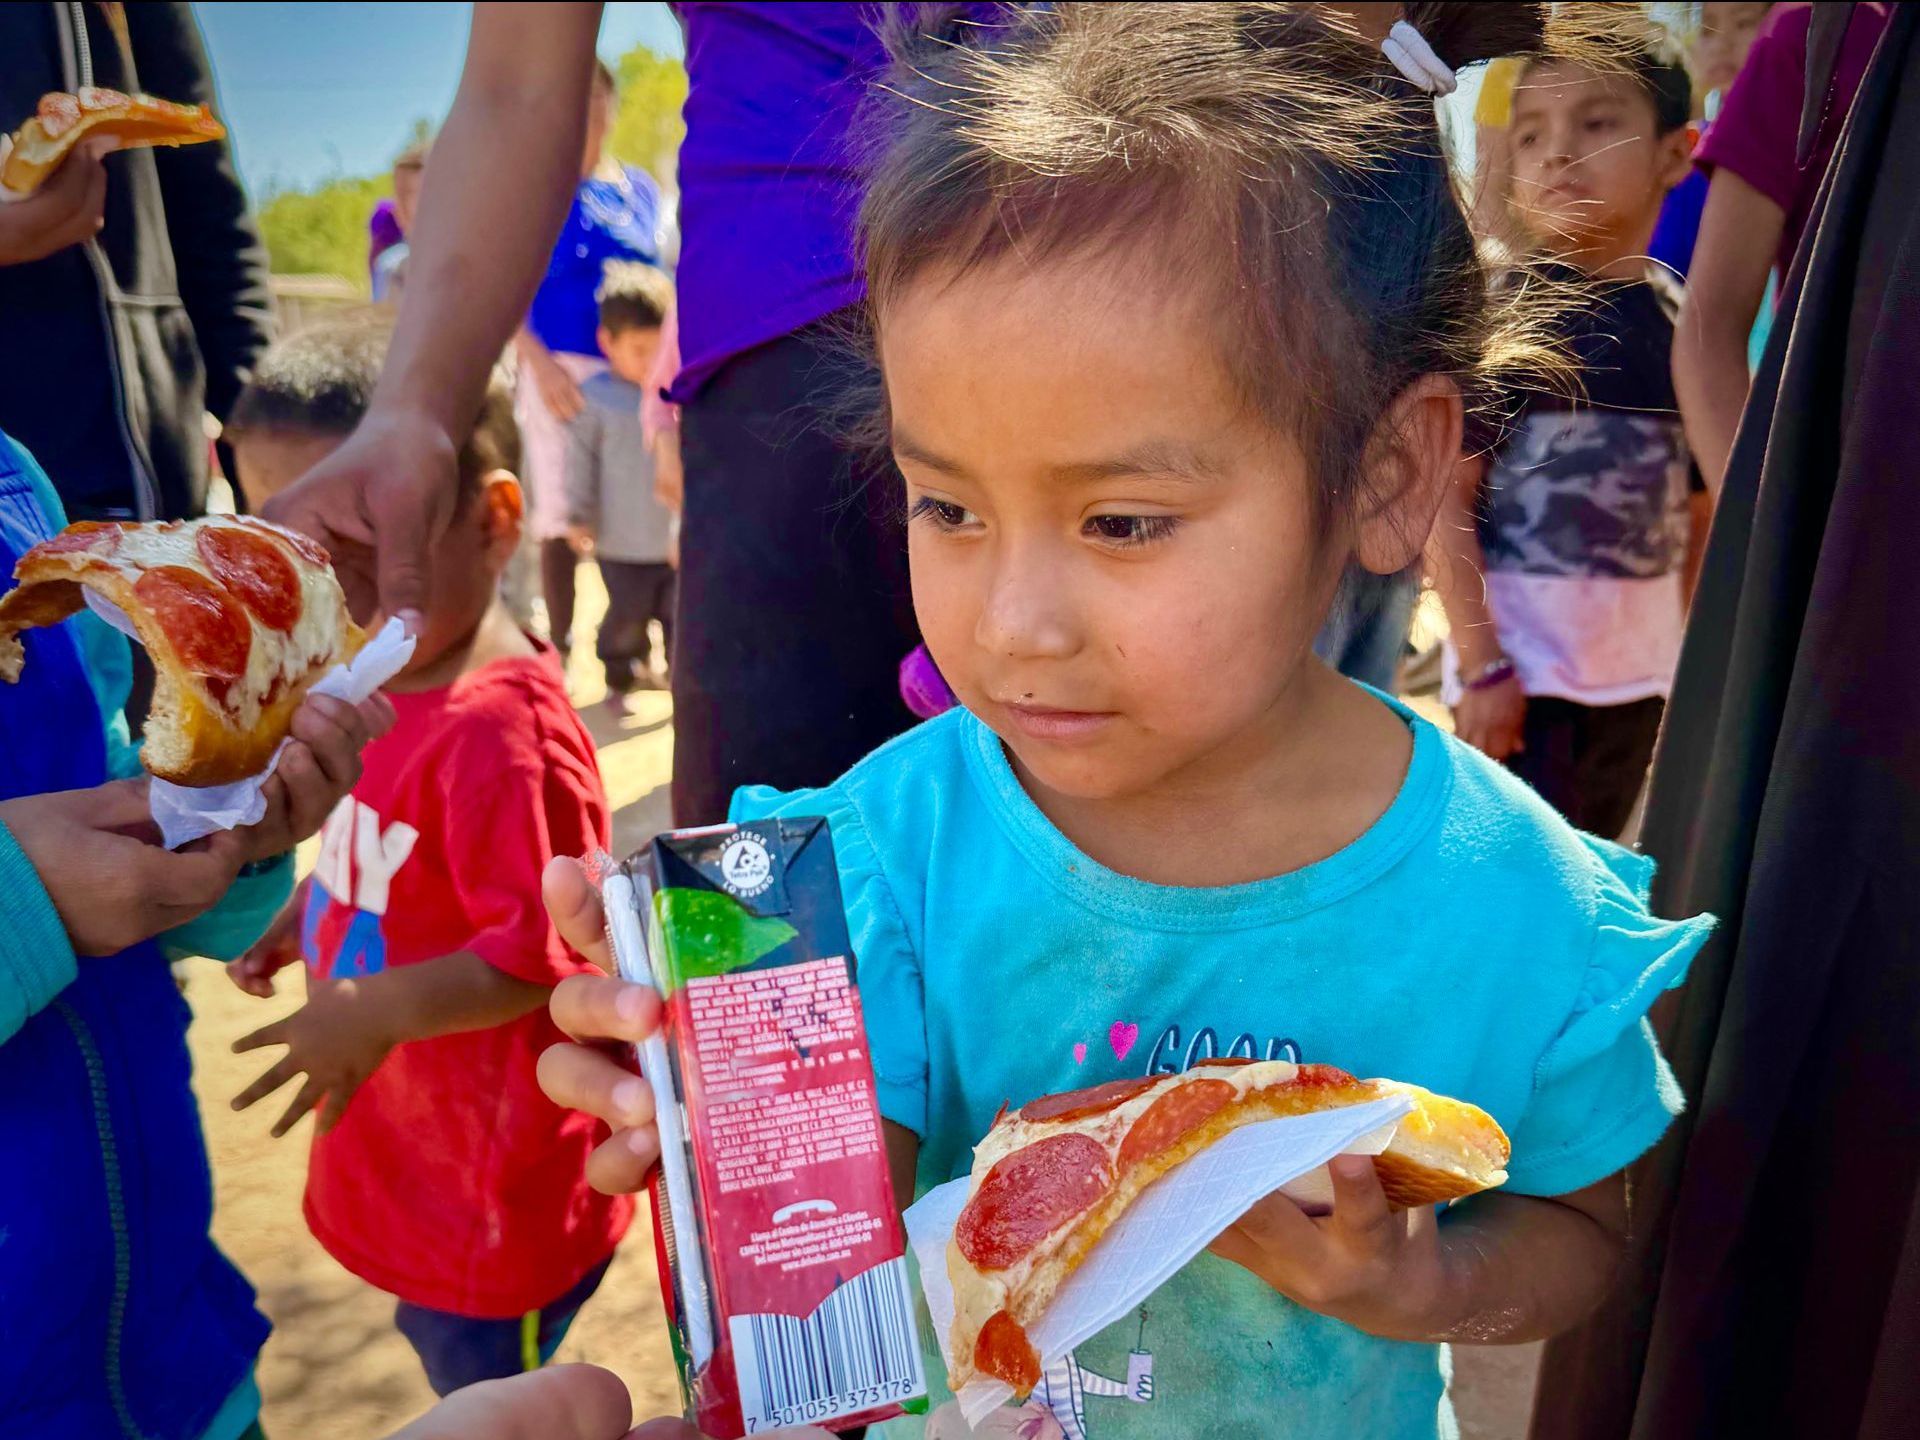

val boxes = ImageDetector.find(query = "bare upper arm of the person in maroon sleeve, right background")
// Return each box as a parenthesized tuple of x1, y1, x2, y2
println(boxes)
(1672, 167, 1786, 495)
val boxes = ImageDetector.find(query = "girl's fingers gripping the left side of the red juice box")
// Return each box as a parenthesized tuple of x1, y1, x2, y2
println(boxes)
(540, 856, 660, 1194)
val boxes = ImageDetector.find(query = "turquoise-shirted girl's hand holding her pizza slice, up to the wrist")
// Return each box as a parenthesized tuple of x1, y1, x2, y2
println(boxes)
(1210, 1156, 1444, 1340)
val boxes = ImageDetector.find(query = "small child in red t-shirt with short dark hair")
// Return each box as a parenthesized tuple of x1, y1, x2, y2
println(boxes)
(230, 321, 632, 1394)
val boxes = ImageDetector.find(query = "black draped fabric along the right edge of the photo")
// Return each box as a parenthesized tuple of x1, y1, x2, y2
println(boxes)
(1532, 6, 1920, 1440)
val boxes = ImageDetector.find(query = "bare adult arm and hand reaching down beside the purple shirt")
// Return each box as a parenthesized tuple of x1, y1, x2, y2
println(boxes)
(267, 0, 601, 616)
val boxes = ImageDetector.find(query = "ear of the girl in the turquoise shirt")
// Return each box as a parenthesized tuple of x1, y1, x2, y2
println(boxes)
(1354, 374, 1465, 574)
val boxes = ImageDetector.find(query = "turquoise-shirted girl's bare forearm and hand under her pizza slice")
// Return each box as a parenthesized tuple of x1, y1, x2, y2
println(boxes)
(1212, 1156, 1626, 1344)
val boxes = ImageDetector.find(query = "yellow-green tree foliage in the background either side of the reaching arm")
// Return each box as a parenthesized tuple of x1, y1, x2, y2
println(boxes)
(259, 46, 687, 278)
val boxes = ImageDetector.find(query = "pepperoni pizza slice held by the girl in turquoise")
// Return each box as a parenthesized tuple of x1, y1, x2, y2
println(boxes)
(947, 1060, 1507, 1396)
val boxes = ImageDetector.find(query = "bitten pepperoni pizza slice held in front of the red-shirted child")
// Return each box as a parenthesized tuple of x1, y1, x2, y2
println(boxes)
(0, 515, 367, 785)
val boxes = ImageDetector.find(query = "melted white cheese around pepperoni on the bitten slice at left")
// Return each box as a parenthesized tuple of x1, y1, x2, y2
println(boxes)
(96, 515, 346, 730)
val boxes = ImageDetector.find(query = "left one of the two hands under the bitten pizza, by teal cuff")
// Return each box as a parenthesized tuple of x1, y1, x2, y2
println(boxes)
(0, 780, 248, 954)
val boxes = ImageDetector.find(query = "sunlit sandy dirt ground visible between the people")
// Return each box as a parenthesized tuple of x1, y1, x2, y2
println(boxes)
(188, 566, 1536, 1440)
